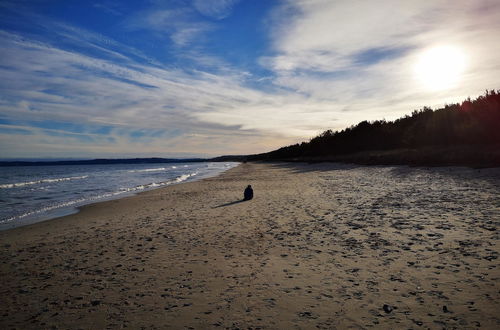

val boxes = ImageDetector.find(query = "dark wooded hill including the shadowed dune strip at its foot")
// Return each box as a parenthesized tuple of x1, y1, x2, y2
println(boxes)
(247, 90, 500, 167)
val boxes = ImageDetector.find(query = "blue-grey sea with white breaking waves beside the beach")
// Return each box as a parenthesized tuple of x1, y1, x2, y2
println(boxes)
(0, 162, 238, 230)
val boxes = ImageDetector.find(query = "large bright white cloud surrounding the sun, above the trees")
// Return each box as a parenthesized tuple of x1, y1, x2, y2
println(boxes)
(260, 0, 500, 114)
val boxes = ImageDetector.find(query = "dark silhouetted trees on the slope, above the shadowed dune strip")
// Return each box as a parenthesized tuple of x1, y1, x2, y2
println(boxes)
(249, 90, 500, 160)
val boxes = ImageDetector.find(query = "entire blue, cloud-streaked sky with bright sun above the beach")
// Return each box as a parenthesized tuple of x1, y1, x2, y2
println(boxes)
(0, 0, 500, 159)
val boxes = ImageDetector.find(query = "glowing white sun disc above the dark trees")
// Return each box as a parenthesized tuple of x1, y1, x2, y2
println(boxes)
(415, 46, 465, 91)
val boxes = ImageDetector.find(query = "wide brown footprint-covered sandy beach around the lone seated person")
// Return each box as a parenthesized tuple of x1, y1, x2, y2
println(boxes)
(0, 163, 500, 329)
